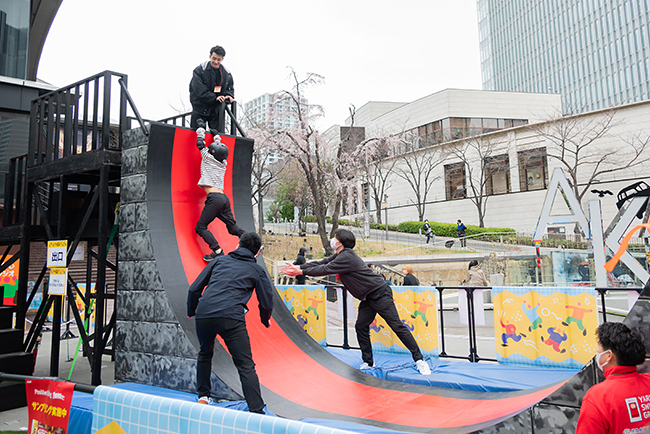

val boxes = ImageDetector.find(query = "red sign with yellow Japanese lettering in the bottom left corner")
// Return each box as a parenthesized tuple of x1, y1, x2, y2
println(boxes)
(25, 379, 74, 434)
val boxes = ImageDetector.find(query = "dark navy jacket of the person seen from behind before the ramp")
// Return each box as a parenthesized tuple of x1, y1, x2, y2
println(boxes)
(187, 247, 274, 321)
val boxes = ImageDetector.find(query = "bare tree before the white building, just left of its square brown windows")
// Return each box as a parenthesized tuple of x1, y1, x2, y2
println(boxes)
(386, 133, 444, 223)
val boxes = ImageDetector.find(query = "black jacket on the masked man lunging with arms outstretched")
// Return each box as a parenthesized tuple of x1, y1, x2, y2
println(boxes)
(300, 247, 387, 300)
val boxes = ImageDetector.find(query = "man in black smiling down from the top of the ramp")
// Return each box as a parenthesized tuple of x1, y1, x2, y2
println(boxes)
(190, 45, 235, 129)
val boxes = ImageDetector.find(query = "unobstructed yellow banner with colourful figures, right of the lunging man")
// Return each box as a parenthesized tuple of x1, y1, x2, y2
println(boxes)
(492, 287, 598, 368)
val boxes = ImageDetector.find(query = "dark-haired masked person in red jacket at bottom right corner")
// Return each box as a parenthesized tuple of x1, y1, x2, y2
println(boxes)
(576, 323, 650, 434)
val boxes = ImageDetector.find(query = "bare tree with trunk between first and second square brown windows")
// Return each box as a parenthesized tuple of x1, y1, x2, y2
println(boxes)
(445, 135, 511, 228)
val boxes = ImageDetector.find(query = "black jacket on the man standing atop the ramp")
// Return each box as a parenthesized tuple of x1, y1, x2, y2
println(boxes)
(190, 60, 235, 115)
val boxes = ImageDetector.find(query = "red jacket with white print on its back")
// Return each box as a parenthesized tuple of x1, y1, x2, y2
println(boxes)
(576, 366, 650, 434)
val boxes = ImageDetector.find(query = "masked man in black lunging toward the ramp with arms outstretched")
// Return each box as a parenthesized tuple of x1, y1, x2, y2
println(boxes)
(281, 229, 431, 375)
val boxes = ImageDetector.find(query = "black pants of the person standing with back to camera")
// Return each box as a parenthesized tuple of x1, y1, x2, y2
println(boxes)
(196, 318, 264, 413)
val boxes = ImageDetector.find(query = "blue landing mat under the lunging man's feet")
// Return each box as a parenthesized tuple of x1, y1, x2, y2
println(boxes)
(327, 347, 579, 392)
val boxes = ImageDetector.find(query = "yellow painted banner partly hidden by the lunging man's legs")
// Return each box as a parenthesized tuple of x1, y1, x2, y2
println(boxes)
(370, 286, 438, 357)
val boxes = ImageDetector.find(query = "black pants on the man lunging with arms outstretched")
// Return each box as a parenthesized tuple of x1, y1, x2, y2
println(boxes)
(355, 285, 423, 366)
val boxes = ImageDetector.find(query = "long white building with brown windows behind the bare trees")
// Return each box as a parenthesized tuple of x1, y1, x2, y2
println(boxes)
(346, 90, 650, 234)
